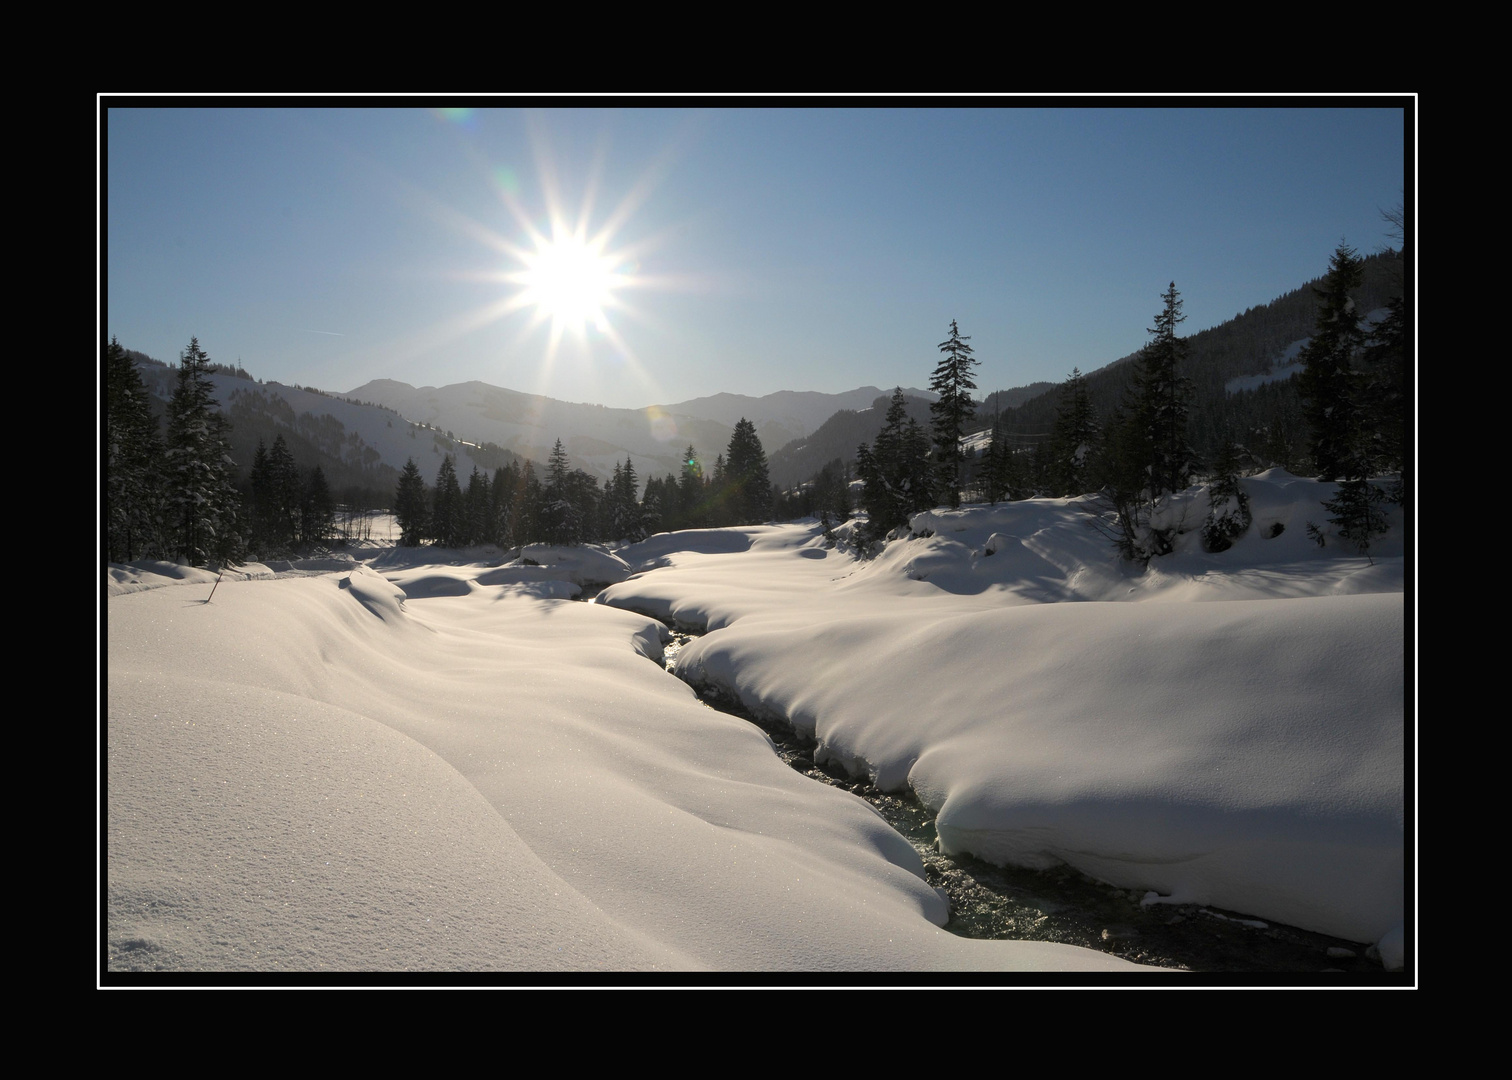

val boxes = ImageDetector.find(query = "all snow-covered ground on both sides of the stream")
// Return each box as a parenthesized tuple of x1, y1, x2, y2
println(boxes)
(103, 472, 1405, 977)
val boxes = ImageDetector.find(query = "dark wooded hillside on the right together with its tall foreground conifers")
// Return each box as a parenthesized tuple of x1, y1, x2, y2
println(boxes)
(840, 237, 1409, 561)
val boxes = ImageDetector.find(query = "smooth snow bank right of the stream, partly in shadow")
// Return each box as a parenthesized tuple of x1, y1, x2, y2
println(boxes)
(599, 470, 1405, 941)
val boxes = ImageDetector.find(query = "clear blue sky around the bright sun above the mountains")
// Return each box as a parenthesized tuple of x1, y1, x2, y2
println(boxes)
(101, 98, 1408, 407)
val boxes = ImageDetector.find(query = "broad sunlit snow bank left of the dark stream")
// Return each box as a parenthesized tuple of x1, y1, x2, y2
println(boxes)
(106, 559, 1137, 973)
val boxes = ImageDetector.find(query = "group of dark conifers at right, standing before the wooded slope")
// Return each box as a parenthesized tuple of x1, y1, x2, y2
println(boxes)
(846, 231, 1409, 561)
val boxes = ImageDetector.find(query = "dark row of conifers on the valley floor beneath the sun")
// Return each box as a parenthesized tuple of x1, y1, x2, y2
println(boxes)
(393, 417, 776, 548)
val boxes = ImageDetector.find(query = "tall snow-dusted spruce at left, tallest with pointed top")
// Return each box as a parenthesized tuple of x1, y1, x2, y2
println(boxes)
(165, 337, 242, 566)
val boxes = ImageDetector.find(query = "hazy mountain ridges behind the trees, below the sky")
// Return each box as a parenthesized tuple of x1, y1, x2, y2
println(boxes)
(120, 253, 1402, 505)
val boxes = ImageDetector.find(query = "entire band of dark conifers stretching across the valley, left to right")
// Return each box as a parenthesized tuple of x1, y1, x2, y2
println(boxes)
(104, 226, 1409, 566)
